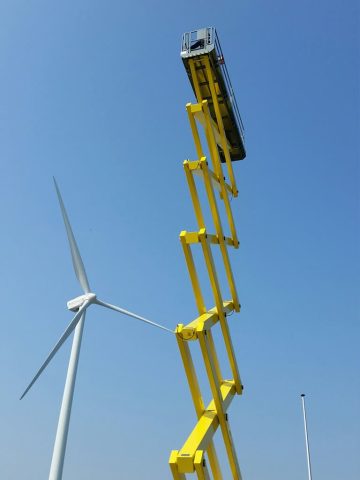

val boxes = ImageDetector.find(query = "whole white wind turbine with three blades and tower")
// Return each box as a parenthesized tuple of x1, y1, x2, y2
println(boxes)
(20, 178, 174, 480)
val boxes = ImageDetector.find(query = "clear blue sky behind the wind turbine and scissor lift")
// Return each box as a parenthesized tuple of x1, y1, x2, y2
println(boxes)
(0, 0, 360, 480)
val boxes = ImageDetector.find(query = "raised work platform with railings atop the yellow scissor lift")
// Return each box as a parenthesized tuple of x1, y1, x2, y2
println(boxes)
(181, 27, 246, 163)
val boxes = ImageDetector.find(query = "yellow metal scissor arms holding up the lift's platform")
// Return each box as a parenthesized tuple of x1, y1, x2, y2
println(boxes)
(169, 44, 243, 480)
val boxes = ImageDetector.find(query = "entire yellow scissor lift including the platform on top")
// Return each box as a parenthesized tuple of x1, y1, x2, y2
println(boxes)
(169, 28, 246, 480)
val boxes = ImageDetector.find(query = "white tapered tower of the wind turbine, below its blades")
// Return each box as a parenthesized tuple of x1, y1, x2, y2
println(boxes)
(49, 311, 85, 480)
